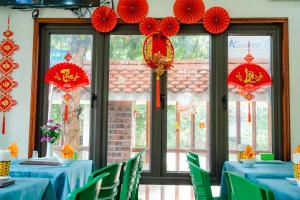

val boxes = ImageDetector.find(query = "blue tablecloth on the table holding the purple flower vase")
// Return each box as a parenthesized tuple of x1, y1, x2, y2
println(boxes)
(10, 160, 93, 200)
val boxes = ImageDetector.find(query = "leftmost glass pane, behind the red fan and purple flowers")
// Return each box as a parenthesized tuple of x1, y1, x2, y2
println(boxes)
(48, 34, 93, 159)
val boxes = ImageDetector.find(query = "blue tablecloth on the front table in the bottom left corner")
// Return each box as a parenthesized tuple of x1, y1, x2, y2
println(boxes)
(0, 178, 56, 200)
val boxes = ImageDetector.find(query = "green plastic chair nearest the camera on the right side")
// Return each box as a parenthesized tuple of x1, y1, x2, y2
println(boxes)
(227, 172, 275, 200)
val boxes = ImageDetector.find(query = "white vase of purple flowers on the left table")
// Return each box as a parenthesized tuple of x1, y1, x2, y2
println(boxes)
(41, 120, 63, 158)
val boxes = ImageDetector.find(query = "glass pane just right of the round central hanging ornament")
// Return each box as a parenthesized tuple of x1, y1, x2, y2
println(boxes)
(167, 35, 210, 171)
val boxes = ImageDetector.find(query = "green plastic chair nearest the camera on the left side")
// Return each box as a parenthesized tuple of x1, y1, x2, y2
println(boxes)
(67, 173, 109, 200)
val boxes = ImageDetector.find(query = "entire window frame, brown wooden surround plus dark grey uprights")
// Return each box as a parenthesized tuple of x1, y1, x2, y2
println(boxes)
(28, 18, 290, 184)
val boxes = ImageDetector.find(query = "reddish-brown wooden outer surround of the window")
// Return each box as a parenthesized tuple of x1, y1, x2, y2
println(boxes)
(28, 18, 291, 183)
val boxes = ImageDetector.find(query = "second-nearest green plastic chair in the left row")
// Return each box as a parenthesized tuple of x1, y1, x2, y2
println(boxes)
(89, 163, 124, 200)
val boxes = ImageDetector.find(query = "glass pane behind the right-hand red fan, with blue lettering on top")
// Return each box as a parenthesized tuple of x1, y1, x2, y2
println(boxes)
(228, 36, 272, 160)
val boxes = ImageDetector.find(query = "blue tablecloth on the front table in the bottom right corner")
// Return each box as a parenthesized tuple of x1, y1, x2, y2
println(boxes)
(256, 179, 300, 200)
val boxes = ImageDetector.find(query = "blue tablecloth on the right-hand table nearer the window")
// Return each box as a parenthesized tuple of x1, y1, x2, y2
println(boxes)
(221, 161, 294, 197)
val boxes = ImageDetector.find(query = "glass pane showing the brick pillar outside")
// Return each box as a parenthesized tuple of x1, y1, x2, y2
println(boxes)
(107, 35, 151, 170)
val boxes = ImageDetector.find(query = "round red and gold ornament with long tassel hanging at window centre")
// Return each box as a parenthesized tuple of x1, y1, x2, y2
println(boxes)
(143, 32, 174, 108)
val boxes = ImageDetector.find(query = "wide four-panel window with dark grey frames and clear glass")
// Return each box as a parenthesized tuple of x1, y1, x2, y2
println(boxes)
(35, 20, 288, 184)
